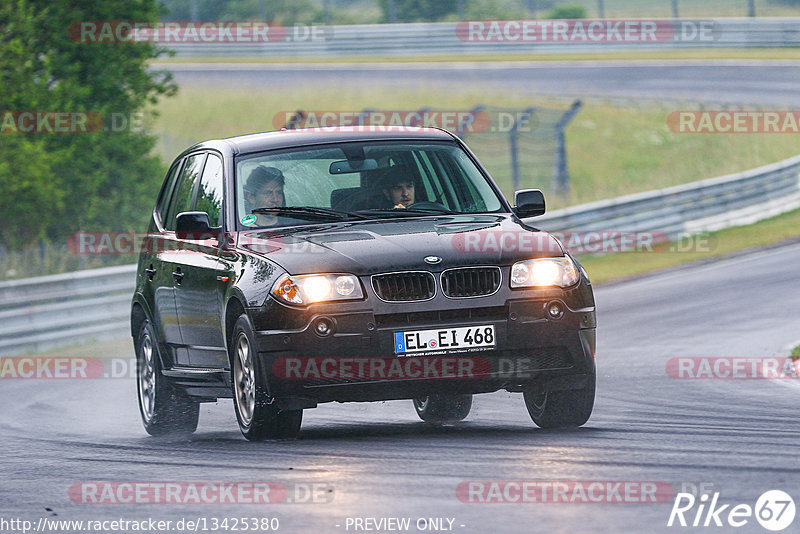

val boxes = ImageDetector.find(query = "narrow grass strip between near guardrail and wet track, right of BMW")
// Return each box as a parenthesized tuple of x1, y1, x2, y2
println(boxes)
(578, 210, 800, 286)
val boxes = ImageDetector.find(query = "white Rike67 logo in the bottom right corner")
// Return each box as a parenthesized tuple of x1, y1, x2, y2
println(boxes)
(667, 490, 795, 532)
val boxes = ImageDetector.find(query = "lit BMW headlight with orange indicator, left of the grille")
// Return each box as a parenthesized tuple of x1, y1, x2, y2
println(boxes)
(271, 274, 364, 304)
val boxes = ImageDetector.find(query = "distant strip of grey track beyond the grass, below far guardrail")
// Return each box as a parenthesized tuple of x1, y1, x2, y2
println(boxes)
(155, 60, 800, 108)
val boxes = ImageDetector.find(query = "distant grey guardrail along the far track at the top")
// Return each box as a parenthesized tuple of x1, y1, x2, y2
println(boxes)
(165, 17, 800, 59)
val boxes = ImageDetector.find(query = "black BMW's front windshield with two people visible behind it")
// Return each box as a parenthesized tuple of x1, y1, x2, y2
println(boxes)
(236, 142, 504, 227)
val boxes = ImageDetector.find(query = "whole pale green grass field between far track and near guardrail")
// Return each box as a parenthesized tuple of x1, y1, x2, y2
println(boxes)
(154, 85, 800, 209)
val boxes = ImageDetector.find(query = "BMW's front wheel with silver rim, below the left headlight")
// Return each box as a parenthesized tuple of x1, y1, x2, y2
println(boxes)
(230, 314, 303, 441)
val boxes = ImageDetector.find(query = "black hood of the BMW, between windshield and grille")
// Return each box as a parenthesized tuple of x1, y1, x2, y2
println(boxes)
(237, 214, 564, 276)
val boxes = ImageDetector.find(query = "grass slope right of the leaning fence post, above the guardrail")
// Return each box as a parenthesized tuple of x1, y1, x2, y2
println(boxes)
(567, 105, 800, 204)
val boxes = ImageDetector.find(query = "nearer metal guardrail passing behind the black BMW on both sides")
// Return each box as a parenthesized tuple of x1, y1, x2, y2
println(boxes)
(0, 156, 800, 356)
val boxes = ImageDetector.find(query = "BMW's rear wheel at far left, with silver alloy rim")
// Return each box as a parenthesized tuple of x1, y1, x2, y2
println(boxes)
(135, 319, 200, 436)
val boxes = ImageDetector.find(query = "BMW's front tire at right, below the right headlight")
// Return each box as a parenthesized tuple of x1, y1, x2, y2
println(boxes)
(523, 374, 596, 428)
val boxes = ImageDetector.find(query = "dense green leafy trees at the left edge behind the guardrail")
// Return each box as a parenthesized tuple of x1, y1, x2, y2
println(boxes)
(0, 0, 176, 248)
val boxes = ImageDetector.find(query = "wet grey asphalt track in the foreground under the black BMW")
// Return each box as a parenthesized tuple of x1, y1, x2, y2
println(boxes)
(0, 245, 800, 534)
